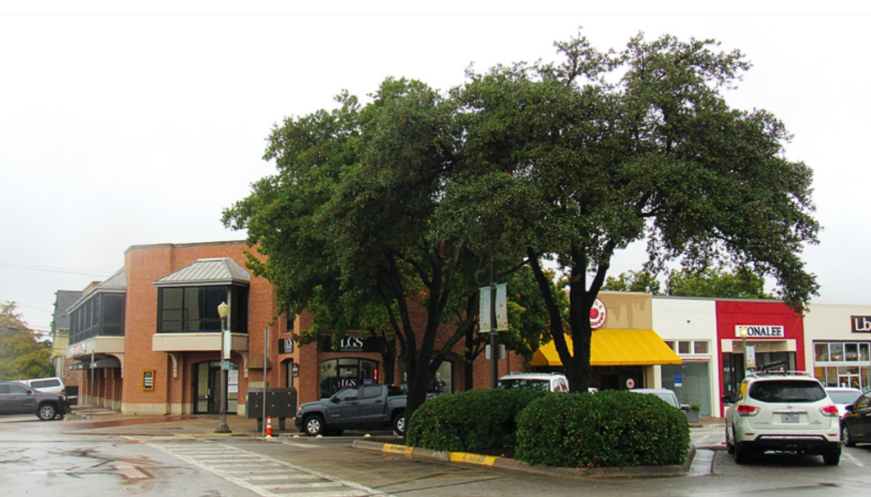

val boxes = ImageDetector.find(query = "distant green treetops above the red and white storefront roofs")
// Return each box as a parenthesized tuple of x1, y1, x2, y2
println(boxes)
(666, 267, 775, 299)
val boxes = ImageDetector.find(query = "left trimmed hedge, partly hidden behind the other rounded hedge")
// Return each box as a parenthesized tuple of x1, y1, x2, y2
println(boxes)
(406, 388, 545, 452)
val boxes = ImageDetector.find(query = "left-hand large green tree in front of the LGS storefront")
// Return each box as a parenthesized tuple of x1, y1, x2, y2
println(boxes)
(223, 78, 541, 419)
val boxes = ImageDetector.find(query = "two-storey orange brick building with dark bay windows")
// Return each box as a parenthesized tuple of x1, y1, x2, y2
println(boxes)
(66, 241, 523, 415)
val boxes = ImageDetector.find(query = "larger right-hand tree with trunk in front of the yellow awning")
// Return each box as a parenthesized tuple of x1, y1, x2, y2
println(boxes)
(455, 31, 819, 391)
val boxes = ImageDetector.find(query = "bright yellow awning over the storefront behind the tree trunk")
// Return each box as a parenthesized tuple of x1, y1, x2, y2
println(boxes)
(531, 330, 682, 366)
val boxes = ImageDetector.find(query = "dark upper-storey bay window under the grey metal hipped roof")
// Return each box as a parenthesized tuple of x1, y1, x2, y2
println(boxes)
(157, 286, 248, 333)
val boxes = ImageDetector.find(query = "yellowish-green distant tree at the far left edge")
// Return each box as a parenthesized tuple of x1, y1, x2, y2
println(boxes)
(0, 302, 52, 381)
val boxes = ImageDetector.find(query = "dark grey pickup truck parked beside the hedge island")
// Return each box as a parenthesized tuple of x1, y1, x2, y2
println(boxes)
(295, 385, 416, 437)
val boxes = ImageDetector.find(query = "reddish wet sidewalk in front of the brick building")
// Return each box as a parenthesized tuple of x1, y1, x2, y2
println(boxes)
(62, 406, 299, 437)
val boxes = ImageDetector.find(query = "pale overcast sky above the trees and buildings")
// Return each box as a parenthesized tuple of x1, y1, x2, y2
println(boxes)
(0, 0, 871, 330)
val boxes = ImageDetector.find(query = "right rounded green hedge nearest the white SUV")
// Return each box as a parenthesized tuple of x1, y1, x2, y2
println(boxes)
(515, 390, 690, 468)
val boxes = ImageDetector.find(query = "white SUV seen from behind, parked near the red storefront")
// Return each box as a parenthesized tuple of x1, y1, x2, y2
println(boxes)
(722, 371, 841, 466)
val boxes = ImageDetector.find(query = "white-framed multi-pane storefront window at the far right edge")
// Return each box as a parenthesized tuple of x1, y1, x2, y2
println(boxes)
(814, 342, 871, 392)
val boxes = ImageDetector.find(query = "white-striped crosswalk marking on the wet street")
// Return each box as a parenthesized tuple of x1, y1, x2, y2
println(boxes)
(131, 437, 393, 497)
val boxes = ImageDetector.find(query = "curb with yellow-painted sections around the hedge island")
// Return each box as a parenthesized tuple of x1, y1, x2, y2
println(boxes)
(351, 440, 696, 479)
